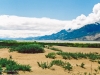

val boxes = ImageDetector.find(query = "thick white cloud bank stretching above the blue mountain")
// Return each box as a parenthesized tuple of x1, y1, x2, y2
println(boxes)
(0, 3, 100, 38)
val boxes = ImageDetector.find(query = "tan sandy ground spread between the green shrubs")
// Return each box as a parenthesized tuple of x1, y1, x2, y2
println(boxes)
(0, 46, 100, 75)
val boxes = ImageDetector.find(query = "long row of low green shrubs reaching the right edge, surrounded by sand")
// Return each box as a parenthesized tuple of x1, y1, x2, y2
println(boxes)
(57, 52, 100, 60)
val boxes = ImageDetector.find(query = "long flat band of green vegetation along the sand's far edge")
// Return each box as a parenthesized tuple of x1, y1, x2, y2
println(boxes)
(0, 40, 100, 48)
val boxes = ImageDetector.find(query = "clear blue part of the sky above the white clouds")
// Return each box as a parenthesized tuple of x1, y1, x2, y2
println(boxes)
(0, 0, 100, 20)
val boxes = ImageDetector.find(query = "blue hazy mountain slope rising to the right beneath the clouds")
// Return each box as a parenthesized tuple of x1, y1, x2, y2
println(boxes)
(34, 23, 100, 40)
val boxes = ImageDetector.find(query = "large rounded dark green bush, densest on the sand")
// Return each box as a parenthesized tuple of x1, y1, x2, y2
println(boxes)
(13, 44, 44, 53)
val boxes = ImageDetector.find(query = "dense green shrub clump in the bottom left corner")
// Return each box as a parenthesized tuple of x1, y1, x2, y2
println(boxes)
(0, 58, 31, 74)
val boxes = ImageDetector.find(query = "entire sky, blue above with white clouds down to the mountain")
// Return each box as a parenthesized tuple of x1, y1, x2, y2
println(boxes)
(0, 0, 100, 38)
